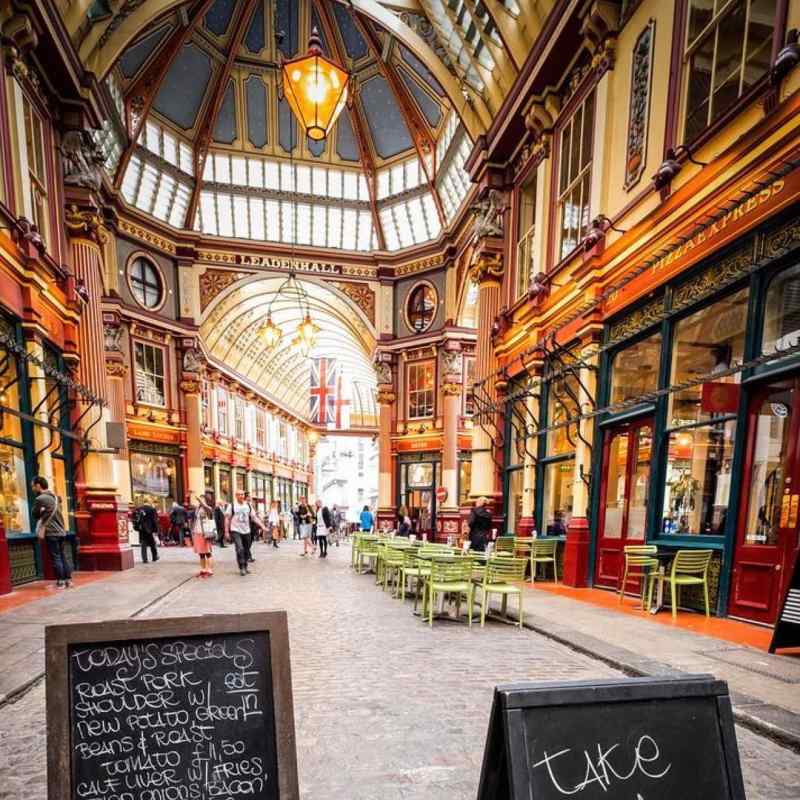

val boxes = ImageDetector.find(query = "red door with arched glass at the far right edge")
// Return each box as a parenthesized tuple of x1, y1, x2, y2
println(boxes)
(728, 377, 800, 623)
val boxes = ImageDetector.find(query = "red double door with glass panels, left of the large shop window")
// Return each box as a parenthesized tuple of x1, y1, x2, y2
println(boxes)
(595, 417, 653, 591)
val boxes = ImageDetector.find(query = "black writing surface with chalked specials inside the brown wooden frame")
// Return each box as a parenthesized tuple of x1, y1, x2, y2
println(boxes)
(69, 632, 278, 800)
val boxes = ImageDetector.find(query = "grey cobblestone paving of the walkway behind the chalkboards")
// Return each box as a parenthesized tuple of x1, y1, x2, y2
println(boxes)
(0, 544, 800, 800)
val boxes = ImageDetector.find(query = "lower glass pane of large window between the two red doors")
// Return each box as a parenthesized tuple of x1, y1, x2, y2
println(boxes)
(663, 420, 736, 536)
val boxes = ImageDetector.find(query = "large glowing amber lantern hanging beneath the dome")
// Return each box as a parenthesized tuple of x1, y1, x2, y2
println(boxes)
(281, 28, 350, 141)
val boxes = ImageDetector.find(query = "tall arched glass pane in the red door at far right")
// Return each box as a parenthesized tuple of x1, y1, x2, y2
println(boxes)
(744, 388, 794, 545)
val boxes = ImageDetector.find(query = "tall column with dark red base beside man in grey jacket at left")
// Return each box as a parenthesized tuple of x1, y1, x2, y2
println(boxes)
(66, 200, 133, 570)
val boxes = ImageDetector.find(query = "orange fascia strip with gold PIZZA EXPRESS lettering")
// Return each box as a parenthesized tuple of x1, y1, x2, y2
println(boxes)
(603, 164, 800, 316)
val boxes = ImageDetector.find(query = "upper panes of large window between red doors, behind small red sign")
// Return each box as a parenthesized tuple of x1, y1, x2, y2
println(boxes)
(667, 288, 748, 428)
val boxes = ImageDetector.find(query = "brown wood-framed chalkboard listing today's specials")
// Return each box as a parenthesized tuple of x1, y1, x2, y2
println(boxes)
(45, 611, 300, 800)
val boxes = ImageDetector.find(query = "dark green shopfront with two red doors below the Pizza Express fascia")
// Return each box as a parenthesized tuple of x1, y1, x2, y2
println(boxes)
(588, 208, 800, 624)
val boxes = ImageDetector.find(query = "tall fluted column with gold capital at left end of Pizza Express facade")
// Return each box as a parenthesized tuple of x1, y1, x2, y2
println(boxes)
(470, 254, 503, 500)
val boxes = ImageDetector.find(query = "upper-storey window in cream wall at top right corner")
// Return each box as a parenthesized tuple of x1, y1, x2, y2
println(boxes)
(684, 0, 776, 142)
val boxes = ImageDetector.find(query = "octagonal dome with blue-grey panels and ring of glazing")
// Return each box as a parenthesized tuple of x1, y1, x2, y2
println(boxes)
(109, 0, 471, 251)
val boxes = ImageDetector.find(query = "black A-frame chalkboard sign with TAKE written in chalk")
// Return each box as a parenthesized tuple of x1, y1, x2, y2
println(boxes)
(478, 675, 745, 800)
